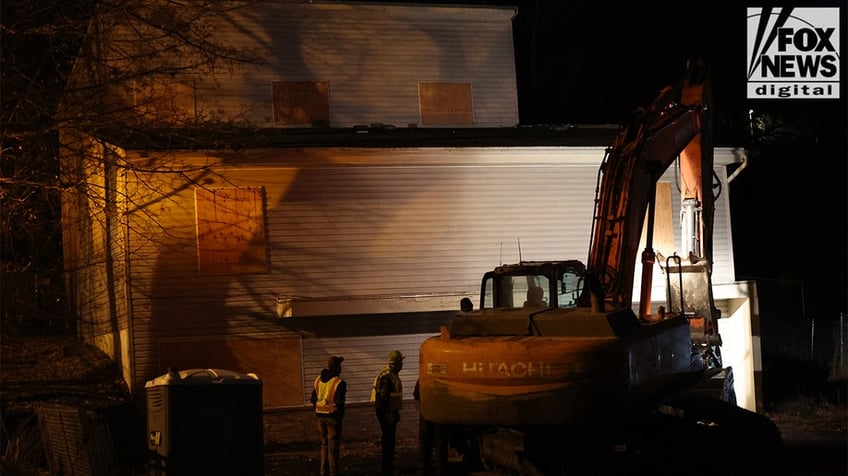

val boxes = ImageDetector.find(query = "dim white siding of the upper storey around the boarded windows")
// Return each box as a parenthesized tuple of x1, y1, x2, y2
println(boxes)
(195, 2, 518, 127)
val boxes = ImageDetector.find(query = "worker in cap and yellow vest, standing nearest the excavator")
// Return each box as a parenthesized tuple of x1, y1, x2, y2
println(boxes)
(371, 350, 404, 476)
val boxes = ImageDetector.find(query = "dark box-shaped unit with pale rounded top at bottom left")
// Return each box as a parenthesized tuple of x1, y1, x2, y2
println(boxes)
(145, 369, 264, 476)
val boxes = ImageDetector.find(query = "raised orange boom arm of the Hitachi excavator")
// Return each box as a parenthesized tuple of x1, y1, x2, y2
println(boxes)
(587, 59, 713, 308)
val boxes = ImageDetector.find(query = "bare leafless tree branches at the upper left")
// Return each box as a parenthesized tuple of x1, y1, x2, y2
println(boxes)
(0, 0, 261, 331)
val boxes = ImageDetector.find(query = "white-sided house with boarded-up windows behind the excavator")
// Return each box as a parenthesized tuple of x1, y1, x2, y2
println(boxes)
(62, 1, 759, 434)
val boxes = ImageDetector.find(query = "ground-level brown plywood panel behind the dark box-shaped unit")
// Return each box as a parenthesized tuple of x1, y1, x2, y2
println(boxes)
(159, 336, 304, 407)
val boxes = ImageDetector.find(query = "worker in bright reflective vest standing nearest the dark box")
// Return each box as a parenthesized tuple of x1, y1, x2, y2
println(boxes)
(310, 356, 347, 476)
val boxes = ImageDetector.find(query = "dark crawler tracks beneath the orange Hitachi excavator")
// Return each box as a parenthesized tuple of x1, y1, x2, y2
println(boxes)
(464, 394, 785, 476)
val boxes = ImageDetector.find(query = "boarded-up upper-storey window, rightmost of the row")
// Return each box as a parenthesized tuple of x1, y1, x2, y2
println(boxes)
(418, 83, 474, 126)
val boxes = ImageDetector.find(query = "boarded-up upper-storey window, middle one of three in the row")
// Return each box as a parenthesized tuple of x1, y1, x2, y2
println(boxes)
(271, 81, 330, 126)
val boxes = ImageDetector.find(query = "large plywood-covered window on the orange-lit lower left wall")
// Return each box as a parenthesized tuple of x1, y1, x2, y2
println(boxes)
(194, 188, 267, 274)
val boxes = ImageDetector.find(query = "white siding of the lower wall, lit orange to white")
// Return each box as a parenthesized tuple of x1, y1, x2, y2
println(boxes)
(124, 147, 744, 397)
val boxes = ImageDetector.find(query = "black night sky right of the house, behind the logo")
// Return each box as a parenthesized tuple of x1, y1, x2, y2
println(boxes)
(496, 0, 848, 319)
